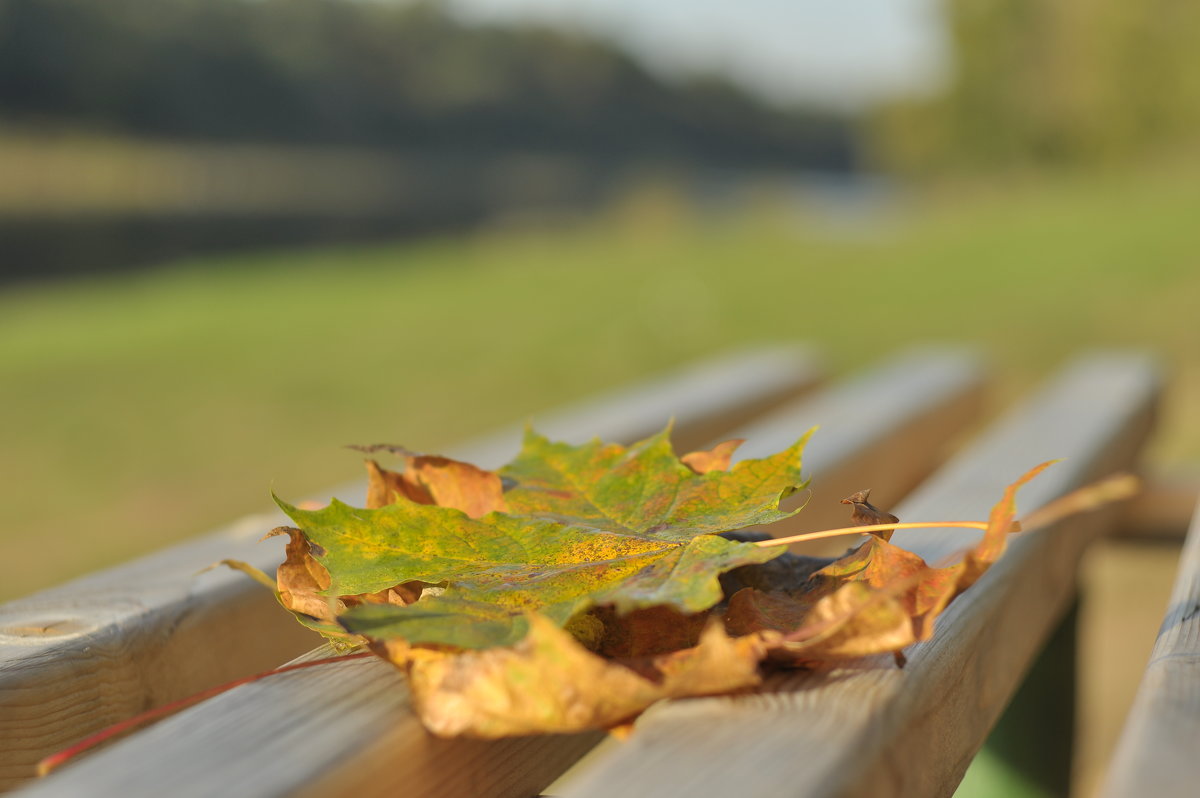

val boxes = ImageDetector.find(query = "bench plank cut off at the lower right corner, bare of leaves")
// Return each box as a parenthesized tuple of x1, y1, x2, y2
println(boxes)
(1102, 506, 1200, 798)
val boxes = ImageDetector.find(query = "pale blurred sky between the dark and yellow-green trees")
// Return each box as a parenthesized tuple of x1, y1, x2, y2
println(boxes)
(448, 0, 948, 110)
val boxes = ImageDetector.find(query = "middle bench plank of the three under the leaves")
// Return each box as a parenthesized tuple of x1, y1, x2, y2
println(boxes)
(11, 353, 980, 798)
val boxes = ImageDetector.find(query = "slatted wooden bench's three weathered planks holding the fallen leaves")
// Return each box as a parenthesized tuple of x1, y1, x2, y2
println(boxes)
(0, 349, 1159, 797)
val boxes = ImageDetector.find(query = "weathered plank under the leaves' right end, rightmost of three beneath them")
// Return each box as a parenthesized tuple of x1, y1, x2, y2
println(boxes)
(565, 356, 1158, 798)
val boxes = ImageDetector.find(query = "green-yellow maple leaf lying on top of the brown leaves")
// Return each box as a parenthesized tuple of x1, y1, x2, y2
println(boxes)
(276, 422, 808, 648)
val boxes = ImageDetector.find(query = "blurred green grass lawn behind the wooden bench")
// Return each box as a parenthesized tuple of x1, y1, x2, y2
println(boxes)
(0, 162, 1200, 598)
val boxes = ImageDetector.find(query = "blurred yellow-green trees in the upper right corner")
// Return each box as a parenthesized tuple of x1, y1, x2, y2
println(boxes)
(870, 0, 1200, 173)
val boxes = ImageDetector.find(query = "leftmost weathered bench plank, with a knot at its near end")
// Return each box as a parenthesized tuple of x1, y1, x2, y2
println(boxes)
(0, 347, 820, 790)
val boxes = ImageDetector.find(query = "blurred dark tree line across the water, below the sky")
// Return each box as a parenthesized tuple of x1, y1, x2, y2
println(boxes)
(0, 0, 854, 169)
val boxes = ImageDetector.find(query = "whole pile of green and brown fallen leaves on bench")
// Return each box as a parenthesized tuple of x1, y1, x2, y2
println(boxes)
(235, 430, 1044, 737)
